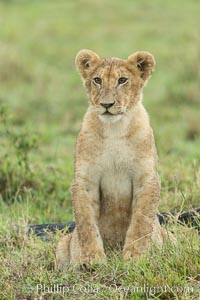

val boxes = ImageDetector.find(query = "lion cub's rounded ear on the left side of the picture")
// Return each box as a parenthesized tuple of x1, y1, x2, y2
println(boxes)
(75, 49, 100, 79)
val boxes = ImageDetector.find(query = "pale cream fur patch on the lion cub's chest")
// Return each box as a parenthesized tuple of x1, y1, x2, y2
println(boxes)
(100, 138, 133, 206)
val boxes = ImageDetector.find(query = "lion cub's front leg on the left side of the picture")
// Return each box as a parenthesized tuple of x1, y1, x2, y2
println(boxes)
(71, 180, 105, 264)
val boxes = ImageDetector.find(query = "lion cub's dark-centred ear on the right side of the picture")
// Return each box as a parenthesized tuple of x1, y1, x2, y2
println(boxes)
(128, 51, 156, 82)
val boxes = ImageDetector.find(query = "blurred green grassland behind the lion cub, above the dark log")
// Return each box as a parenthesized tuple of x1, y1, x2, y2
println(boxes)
(0, 0, 200, 223)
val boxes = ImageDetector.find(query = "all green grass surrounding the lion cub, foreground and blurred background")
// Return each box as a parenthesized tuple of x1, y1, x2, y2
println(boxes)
(0, 0, 200, 299)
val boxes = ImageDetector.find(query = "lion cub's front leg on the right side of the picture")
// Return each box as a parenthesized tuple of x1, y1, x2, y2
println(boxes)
(123, 176, 160, 260)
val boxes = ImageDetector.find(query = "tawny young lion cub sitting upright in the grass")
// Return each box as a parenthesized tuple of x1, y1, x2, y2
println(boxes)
(56, 50, 170, 269)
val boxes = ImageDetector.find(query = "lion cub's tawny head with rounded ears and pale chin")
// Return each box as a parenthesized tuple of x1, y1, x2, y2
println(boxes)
(76, 50, 155, 122)
